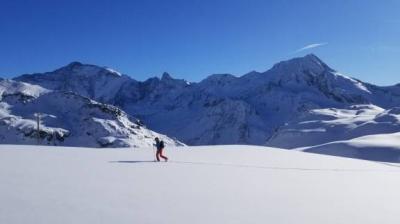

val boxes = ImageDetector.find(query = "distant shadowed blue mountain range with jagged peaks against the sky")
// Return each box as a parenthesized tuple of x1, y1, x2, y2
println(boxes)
(16, 54, 400, 146)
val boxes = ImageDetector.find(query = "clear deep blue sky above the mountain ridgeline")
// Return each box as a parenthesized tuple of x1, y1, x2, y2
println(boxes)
(0, 0, 400, 85)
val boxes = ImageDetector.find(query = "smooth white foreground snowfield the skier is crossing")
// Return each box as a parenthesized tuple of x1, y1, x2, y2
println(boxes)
(0, 145, 400, 224)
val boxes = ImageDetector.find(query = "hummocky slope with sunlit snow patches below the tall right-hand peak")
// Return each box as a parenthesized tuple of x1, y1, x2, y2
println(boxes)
(267, 104, 400, 148)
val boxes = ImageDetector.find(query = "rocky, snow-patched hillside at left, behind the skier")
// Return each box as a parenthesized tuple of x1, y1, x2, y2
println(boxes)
(0, 80, 181, 147)
